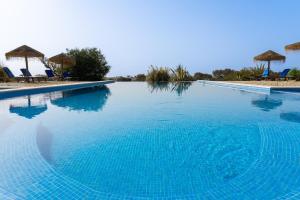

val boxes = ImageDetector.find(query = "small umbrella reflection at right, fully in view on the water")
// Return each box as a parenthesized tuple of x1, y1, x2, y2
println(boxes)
(251, 95, 282, 112)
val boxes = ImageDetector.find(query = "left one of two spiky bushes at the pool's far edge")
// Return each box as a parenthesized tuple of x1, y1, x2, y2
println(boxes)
(147, 65, 171, 82)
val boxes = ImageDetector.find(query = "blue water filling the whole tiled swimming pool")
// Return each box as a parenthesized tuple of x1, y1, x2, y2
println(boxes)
(0, 82, 300, 200)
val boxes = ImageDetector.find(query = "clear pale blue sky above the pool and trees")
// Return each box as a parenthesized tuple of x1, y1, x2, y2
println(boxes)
(0, 0, 300, 76)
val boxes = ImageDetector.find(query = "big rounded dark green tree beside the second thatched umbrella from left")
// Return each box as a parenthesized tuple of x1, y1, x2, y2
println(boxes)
(67, 48, 110, 81)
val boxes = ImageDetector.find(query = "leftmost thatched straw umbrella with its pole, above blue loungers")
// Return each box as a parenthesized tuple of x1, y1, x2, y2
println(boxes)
(5, 45, 44, 76)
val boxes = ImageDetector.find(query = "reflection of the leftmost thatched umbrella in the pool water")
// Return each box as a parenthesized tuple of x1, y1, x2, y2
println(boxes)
(9, 95, 47, 119)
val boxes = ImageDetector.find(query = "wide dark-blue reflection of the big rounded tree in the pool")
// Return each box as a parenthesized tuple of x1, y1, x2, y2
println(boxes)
(51, 86, 111, 111)
